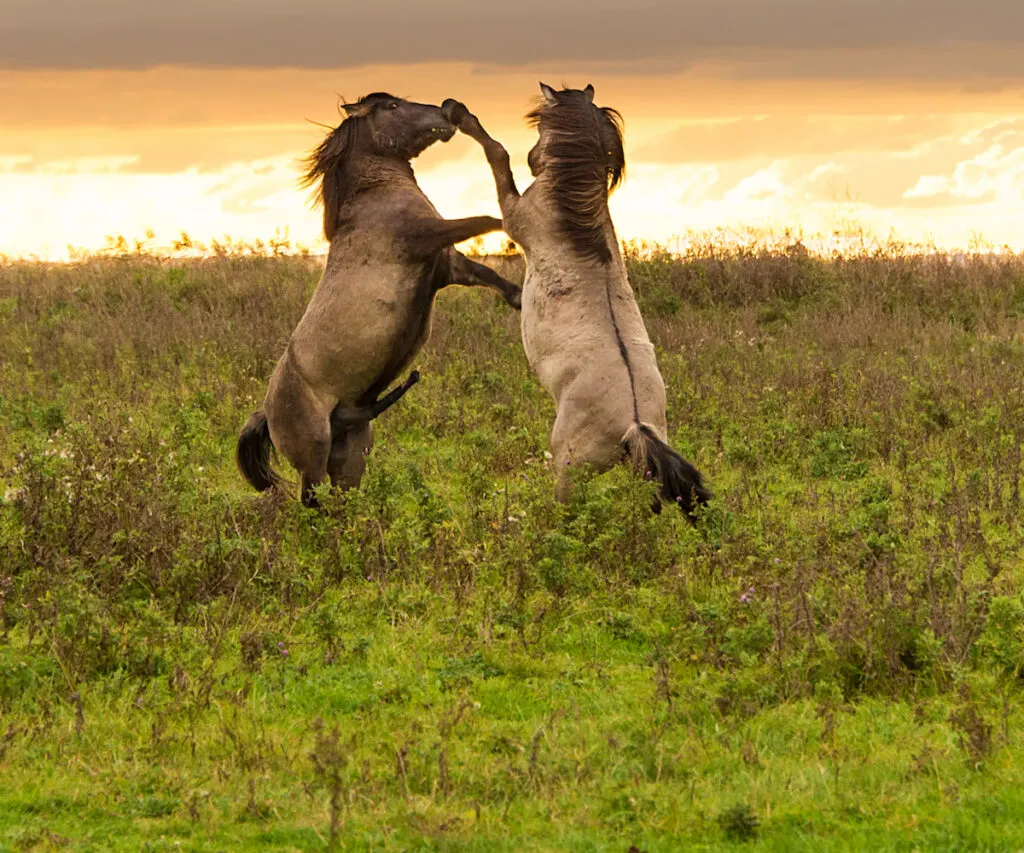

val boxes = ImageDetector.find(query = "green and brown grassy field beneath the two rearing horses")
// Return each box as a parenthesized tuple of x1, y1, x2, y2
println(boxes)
(0, 246, 1024, 853)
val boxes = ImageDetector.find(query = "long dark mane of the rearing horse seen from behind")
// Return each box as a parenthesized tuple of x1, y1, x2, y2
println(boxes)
(526, 89, 626, 263)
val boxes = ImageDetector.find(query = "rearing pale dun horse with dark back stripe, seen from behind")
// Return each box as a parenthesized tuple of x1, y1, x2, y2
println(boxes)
(442, 83, 710, 519)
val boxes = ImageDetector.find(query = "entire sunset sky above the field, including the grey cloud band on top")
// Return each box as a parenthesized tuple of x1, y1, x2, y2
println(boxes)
(0, 0, 1024, 258)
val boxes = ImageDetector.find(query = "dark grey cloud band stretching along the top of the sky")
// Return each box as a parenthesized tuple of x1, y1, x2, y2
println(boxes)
(6, 0, 1024, 78)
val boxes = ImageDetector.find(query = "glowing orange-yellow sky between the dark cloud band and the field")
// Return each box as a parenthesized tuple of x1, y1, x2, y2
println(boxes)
(0, 56, 1024, 258)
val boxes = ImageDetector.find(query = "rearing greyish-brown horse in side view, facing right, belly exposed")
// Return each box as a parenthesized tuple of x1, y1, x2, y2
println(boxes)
(236, 92, 520, 506)
